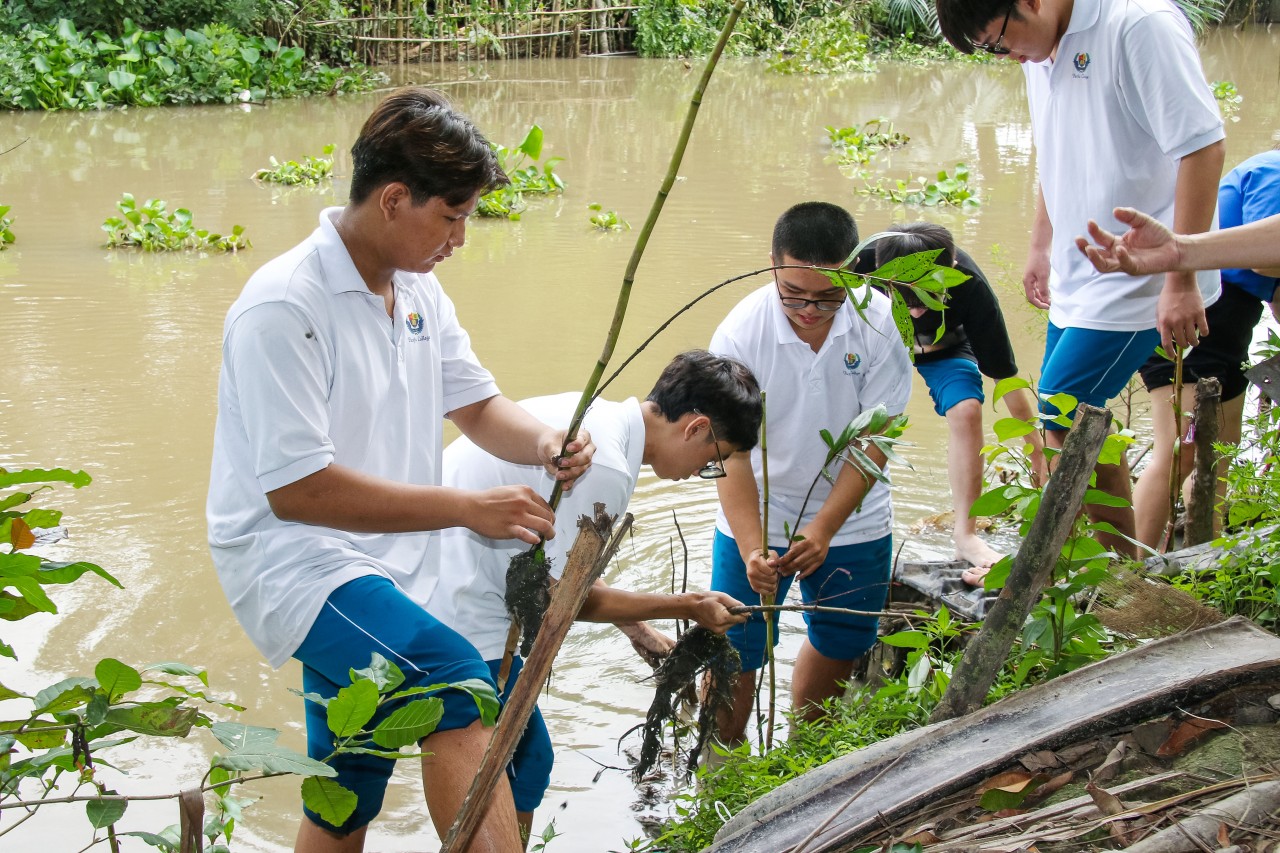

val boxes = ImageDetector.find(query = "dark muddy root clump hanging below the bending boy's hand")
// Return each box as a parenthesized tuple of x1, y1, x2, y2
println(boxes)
(623, 625, 742, 781)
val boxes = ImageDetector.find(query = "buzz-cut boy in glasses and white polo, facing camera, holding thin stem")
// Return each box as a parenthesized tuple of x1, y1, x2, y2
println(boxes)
(710, 201, 911, 743)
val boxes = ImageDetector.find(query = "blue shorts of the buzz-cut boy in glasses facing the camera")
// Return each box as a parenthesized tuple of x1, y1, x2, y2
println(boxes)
(712, 530, 893, 672)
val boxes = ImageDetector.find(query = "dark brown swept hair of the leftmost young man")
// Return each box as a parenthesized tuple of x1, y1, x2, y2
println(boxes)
(351, 86, 509, 206)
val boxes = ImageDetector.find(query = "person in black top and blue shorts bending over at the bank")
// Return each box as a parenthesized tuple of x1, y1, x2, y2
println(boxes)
(856, 222, 1044, 585)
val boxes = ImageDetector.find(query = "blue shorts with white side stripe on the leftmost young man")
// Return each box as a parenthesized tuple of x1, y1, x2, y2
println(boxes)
(293, 575, 497, 835)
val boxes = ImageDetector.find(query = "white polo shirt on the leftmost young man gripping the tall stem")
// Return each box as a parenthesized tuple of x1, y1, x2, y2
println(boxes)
(206, 207, 498, 666)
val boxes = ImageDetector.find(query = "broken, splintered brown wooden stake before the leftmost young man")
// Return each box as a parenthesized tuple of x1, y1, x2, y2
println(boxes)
(442, 503, 632, 853)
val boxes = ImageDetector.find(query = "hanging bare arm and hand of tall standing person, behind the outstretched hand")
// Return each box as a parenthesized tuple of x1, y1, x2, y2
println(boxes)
(1156, 141, 1226, 352)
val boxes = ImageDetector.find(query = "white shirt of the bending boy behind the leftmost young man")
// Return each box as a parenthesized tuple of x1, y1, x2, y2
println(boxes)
(426, 392, 645, 661)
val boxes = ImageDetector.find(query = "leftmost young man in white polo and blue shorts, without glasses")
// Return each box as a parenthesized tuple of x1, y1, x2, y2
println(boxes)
(207, 88, 591, 853)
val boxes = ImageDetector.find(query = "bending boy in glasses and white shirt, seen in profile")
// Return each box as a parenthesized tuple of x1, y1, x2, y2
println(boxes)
(426, 350, 762, 838)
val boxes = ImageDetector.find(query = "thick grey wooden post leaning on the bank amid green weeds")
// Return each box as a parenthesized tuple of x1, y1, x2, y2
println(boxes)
(929, 403, 1111, 722)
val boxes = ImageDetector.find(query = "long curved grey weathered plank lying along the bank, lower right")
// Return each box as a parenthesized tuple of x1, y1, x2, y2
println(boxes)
(707, 617, 1280, 853)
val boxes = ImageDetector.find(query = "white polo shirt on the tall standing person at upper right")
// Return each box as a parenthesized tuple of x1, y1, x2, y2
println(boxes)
(1023, 0, 1224, 332)
